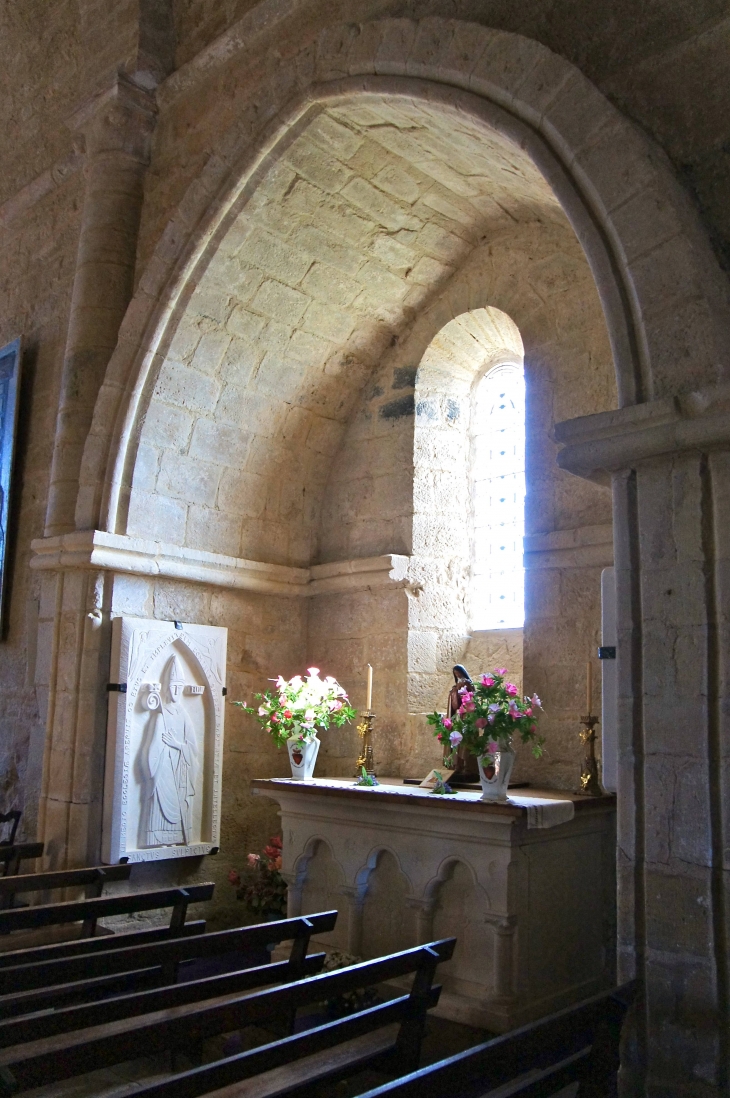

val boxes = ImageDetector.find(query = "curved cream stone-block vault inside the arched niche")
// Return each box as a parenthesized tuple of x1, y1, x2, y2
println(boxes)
(127, 96, 574, 564)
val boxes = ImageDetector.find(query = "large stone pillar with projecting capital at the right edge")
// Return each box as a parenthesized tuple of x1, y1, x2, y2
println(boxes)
(559, 397, 730, 1096)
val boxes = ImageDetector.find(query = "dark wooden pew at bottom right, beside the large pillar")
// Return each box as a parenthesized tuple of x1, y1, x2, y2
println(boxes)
(351, 983, 636, 1098)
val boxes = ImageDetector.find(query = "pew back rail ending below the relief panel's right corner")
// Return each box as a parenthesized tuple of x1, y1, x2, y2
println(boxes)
(0, 883, 214, 937)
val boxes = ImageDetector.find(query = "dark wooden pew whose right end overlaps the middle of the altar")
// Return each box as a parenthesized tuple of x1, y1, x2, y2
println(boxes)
(0, 939, 456, 1096)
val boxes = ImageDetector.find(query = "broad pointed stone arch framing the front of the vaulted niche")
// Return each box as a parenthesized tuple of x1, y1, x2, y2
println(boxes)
(77, 19, 730, 531)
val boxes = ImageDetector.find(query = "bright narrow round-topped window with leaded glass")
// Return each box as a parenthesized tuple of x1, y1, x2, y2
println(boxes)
(471, 363, 525, 629)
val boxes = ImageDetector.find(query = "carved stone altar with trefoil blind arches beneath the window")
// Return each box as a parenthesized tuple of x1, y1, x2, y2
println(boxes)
(252, 778, 616, 1032)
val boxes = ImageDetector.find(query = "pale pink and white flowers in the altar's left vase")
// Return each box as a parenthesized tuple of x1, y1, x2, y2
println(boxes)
(234, 668, 356, 748)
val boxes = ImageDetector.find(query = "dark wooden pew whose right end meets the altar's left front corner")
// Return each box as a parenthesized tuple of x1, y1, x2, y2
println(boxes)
(0, 911, 337, 1010)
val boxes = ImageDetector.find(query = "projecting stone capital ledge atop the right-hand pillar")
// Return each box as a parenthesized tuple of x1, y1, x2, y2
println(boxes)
(554, 385, 730, 483)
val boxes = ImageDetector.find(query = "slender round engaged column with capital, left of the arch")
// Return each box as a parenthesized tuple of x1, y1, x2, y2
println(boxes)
(45, 76, 156, 536)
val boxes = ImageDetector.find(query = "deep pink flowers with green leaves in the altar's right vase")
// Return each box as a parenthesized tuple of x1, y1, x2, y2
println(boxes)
(426, 668, 544, 759)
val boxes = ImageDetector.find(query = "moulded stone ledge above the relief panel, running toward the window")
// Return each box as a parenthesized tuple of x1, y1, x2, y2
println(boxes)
(31, 530, 409, 597)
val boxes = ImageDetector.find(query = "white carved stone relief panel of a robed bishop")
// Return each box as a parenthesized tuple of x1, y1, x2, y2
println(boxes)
(102, 616, 227, 863)
